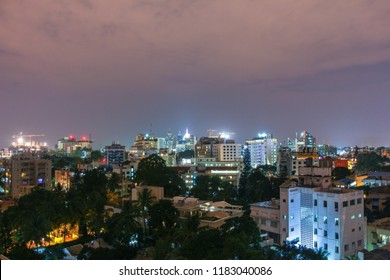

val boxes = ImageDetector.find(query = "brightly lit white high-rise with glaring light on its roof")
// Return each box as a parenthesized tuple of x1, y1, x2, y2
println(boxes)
(246, 133, 278, 168)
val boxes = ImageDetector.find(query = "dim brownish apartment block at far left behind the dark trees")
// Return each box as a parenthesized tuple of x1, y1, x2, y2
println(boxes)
(11, 153, 52, 197)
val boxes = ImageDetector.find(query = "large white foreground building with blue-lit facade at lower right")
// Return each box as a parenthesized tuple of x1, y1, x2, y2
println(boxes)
(251, 167, 365, 259)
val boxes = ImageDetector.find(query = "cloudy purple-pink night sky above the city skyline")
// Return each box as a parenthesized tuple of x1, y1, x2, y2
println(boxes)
(0, 0, 390, 148)
